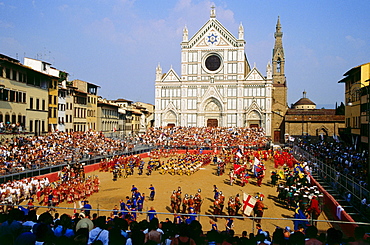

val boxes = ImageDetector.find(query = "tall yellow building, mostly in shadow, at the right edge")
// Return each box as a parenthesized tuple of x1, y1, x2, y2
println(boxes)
(338, 63, 370, 150)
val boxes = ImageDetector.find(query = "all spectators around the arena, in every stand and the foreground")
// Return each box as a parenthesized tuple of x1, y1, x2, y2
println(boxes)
(0, 127, 369, 245)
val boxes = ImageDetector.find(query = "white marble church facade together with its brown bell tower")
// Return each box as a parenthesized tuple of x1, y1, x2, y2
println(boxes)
(155, 8, 287, 141)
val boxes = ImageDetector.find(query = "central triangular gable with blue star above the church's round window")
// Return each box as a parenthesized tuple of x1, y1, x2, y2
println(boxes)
(187, 19, 238, 48)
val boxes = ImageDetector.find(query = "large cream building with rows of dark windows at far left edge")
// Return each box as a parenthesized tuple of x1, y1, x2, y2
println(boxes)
(0, 54, 59, 135)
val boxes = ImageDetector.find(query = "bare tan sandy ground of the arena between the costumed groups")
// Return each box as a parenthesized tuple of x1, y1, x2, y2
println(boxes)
(48, 155, 332, 235)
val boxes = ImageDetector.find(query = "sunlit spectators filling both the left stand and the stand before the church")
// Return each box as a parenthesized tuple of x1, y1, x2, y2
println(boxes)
(0, 127, 269, 175)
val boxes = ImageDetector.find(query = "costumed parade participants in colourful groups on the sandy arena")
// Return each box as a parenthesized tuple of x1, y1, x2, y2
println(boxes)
(0, 124, 322, 237)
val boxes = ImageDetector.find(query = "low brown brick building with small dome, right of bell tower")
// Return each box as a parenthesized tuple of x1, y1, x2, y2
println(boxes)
(283, 92, 345, 139)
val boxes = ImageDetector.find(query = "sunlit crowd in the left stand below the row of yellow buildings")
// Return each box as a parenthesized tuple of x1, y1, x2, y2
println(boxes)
(0, 131, 132, 175)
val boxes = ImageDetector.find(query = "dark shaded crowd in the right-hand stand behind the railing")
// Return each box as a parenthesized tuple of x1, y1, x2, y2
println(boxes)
(299, 141, 369, 186)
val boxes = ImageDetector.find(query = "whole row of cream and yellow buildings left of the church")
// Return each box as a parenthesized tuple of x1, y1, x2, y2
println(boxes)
(0, 54, 154, 137)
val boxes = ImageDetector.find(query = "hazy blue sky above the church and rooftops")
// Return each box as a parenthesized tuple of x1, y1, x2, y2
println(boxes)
(0, 0, 370, 109)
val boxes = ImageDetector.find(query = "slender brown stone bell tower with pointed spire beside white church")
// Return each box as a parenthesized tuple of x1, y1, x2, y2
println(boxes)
(272, 17, 288, 142)
